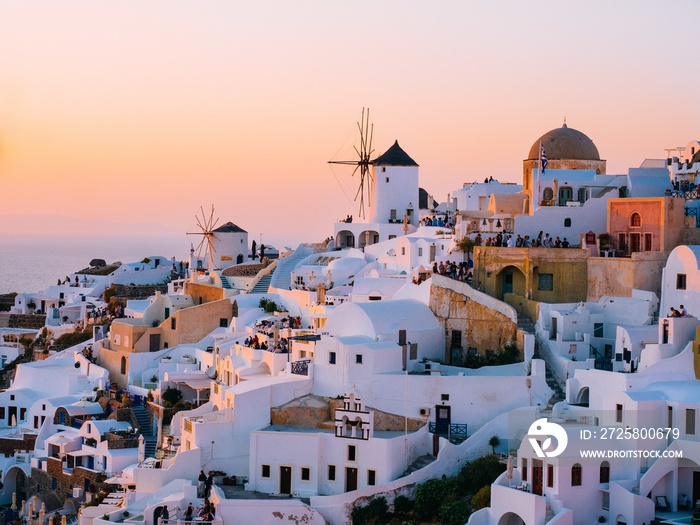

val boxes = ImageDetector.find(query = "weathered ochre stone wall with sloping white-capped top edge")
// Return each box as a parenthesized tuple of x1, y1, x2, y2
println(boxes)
(429, 276, 522, 365)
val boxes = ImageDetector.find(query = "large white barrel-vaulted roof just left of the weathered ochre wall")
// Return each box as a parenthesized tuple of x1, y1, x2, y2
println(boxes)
(324, 299, 440, 339)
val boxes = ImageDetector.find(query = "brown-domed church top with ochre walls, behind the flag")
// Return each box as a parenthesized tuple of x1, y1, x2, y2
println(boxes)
(523, 121, 605, 212)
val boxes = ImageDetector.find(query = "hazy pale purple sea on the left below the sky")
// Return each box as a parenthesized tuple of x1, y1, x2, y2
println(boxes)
(0, 235, 191, 294)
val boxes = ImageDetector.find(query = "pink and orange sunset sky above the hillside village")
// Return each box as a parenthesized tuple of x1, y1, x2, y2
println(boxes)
(0, 0, 700, 245)
